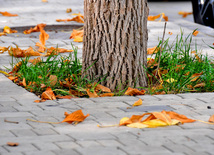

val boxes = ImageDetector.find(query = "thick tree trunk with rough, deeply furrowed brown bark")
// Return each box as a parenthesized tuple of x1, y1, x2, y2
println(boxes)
(82, 0, 148, 90)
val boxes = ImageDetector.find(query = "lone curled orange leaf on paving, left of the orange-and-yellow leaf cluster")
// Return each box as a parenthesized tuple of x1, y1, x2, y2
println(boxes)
(62, 109, 89, 123)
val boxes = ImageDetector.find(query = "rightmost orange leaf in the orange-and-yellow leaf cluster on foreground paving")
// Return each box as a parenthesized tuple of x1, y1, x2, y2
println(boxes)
(166, 111, 196, 123)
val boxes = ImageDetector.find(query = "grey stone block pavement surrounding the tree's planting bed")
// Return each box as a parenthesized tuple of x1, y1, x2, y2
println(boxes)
(0, 0, 214, 155)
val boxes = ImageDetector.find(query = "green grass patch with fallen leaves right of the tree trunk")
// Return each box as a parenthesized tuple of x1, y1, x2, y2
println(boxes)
(147, 33, 214, 94)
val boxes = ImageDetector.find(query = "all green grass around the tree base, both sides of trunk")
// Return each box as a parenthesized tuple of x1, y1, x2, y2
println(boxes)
(7, 33, 214, 97)
